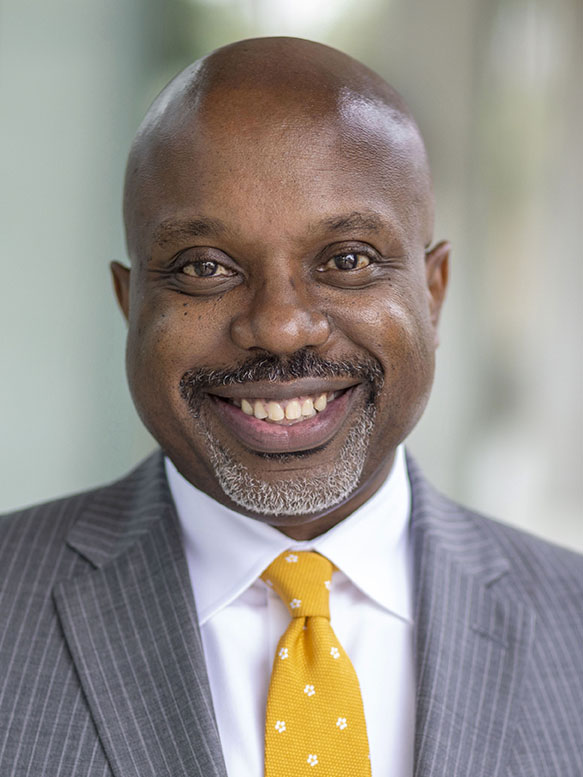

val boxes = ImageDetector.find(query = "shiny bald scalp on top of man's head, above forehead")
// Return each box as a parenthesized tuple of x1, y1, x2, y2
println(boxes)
(124, 38, 433, 258)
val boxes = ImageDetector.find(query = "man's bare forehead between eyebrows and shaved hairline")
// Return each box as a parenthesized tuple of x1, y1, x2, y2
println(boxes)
(128, 90, 427, 258)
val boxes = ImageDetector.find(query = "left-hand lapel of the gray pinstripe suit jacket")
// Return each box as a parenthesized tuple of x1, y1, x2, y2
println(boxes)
(55, 455, 226, 777)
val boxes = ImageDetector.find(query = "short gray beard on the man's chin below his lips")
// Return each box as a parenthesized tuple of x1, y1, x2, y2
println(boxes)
(208, 403, 375, 516)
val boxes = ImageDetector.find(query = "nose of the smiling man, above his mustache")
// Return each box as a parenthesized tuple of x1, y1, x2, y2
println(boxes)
(231, 278, 330, 354)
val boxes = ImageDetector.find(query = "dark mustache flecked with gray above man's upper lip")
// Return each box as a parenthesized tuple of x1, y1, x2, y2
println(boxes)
(179, 348, 384, 414)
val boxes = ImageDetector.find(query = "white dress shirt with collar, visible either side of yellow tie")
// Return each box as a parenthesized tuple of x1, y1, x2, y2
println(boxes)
(166, 448, 415, 777)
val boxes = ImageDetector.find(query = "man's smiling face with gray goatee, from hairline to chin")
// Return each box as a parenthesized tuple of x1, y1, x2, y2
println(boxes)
(114, 41, 447, 539)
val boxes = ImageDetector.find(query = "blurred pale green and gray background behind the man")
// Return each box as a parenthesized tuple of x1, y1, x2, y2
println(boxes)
(0, 0, 583, 550)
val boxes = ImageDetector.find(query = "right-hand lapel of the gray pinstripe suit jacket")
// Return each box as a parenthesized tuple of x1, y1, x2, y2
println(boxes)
(409, 454, 534, 777)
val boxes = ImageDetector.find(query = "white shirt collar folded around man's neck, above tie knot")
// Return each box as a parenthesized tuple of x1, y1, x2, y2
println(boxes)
(165, 446, 413, 626)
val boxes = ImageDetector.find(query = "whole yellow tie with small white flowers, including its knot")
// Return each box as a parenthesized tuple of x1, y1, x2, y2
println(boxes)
(261, 551, 371, 777)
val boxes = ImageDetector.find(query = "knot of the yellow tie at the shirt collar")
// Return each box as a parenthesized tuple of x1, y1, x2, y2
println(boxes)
(261, 551, 334, 619)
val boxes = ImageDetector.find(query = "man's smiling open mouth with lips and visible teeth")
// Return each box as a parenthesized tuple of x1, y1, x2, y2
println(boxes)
(208, 381, 362, 453)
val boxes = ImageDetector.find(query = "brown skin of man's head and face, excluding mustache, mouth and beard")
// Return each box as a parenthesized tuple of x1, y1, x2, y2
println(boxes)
(112, 38, 449, 539)
